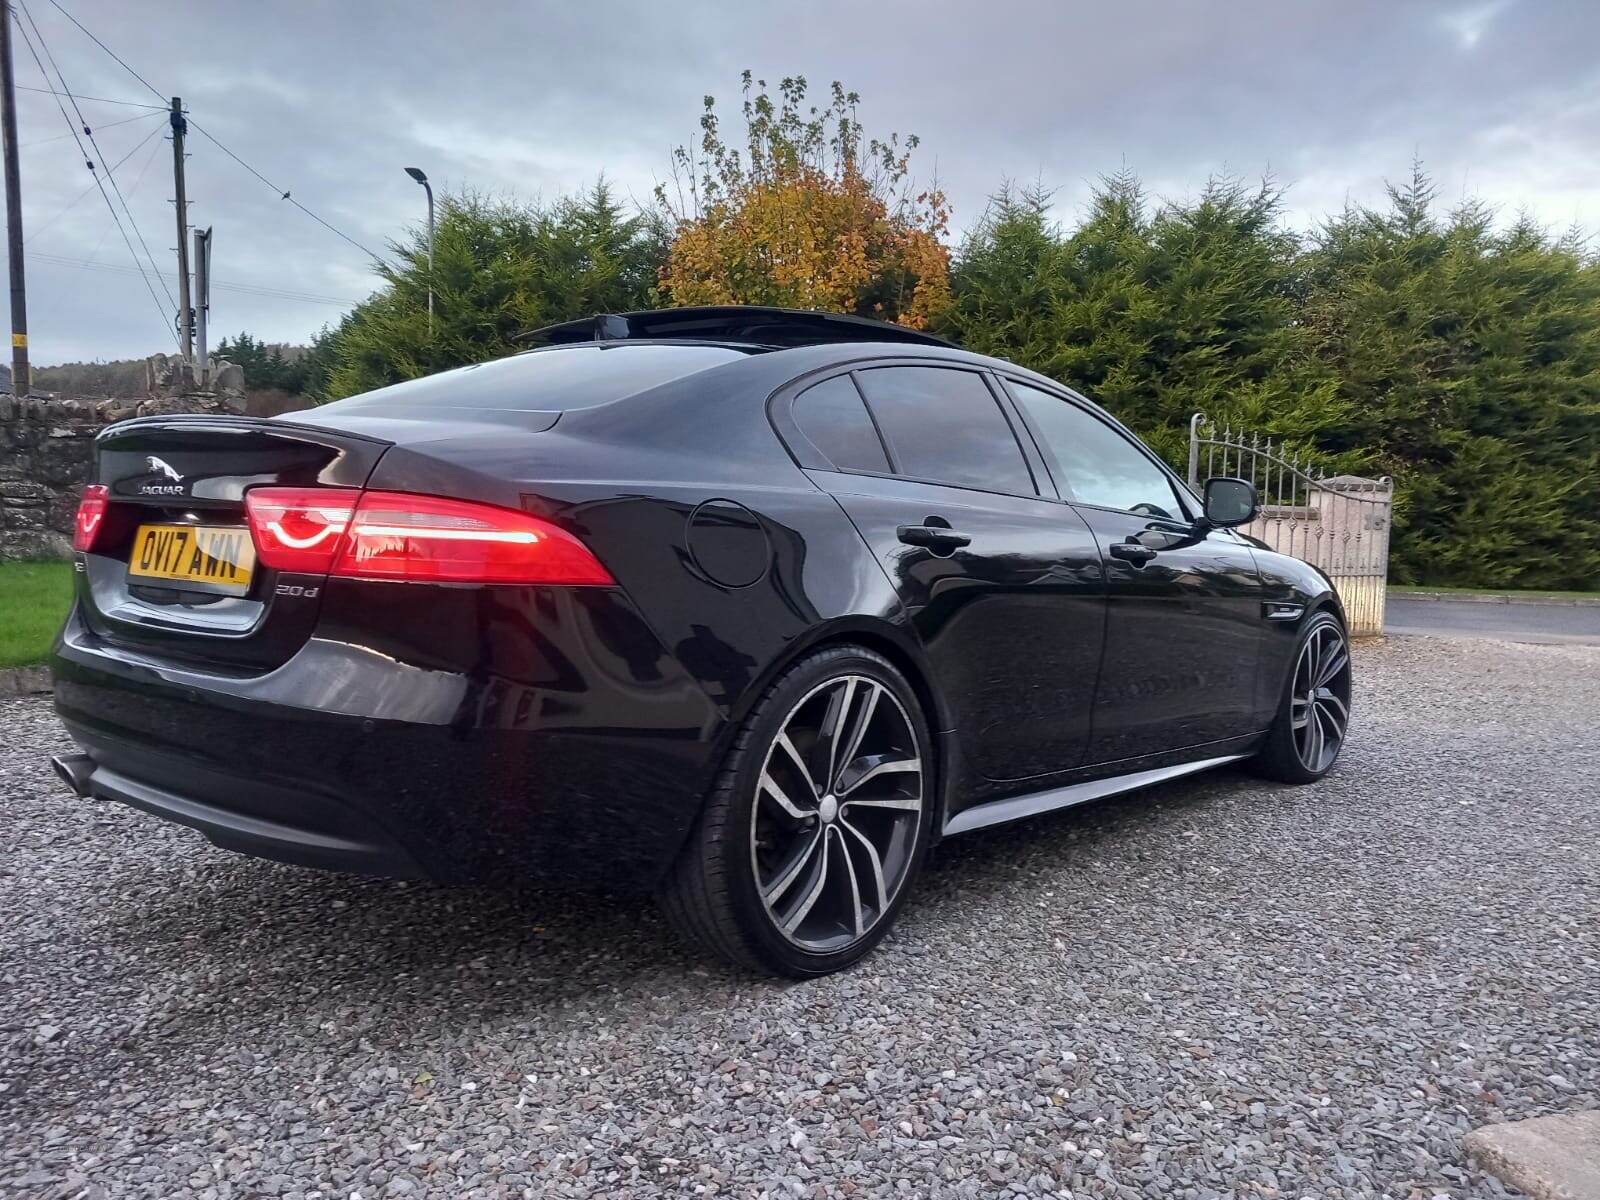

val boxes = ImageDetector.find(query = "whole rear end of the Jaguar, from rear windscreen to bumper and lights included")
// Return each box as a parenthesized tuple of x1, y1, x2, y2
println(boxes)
(54, 346, 742, 885)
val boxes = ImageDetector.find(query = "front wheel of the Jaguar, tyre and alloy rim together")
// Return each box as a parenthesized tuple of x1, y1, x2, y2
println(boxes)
(1251, 613, 1350, 784)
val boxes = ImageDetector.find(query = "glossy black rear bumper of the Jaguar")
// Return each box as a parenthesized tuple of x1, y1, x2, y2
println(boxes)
(53, 592, 720, 890)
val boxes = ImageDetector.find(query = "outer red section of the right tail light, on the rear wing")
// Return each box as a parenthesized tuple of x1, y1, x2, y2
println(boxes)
(334, 491, 614, 587)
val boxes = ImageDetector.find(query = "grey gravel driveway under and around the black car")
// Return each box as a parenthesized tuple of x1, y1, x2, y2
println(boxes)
(0, 640, 1600, 1200)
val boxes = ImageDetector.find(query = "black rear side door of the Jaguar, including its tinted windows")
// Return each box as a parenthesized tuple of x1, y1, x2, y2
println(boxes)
(790, 365, 1104, 781)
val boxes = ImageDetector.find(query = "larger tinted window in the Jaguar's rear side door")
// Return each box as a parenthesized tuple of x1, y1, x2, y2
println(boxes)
(859, 366, 1035, 496)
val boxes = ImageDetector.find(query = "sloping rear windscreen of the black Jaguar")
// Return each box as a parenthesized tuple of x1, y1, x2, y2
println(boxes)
(317, 344, 750, 413)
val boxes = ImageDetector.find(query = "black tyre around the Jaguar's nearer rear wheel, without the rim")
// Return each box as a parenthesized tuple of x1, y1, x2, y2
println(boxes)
(725, 646, 938, 978)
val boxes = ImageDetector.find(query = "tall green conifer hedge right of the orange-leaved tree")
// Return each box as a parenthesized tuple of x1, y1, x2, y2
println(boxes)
(941, 171, 1600, 590)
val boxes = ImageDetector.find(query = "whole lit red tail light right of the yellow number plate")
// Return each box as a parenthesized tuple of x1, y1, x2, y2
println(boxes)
(245, 488, 614, 587)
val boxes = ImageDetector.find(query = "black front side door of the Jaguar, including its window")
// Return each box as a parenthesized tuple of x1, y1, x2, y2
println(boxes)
(1006, 379, 1264, 763)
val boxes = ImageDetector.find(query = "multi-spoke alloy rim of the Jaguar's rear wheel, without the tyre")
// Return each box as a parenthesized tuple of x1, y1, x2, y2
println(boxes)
(750, 675, 923, 954)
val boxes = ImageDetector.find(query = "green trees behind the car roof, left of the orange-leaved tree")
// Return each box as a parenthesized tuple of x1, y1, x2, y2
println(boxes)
(320, 179, 666, 398)
